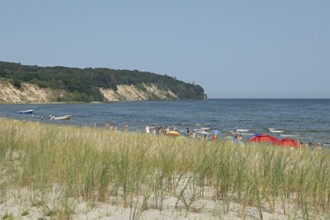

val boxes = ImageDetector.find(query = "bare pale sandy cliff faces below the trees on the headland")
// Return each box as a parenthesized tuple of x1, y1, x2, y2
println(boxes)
(0, 81, 178, 103)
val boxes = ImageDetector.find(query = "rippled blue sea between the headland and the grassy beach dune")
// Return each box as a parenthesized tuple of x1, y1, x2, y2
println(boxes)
(0, 99, 330, 145)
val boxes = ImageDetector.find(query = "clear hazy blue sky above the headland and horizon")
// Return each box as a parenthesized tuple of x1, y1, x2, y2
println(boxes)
(0, 0, 330, 98)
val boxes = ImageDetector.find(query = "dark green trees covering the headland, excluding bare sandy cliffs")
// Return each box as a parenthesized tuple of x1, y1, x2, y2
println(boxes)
(0, 61, 204, 102)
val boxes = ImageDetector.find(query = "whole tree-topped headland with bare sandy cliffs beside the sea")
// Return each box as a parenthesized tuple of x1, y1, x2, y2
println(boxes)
(0, 61, 206, 103)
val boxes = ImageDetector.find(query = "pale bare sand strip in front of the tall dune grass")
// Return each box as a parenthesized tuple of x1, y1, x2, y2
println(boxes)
(0, 186, 318, 220)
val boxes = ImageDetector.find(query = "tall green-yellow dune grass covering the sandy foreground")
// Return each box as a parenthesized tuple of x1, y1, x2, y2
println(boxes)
(0, 118, 330, 219)
